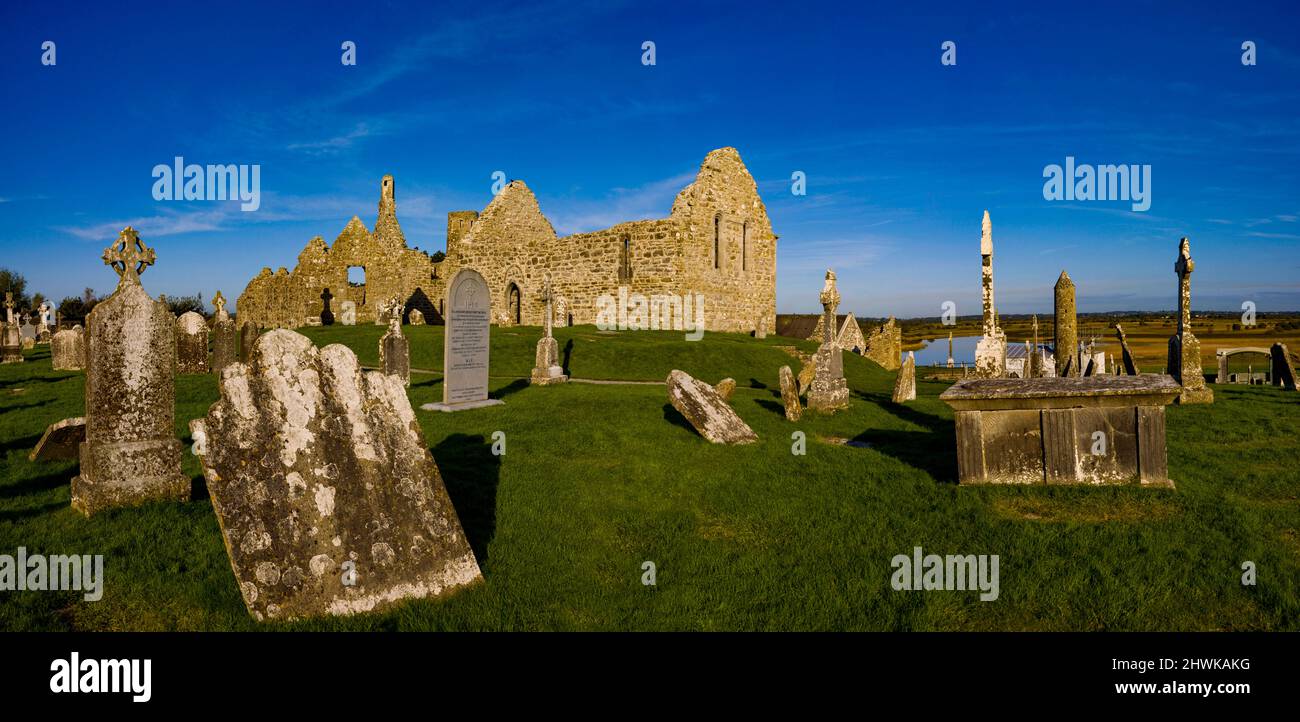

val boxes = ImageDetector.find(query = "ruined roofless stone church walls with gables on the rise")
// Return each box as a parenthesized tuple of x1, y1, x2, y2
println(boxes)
(238, 148, 776, 333)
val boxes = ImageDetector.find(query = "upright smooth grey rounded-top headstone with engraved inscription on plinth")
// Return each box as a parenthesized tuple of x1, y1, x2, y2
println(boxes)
(420, 268, 503, 411)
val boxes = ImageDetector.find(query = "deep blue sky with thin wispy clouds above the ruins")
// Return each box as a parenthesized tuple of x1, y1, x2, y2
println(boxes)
(0, 0, 1300, 316)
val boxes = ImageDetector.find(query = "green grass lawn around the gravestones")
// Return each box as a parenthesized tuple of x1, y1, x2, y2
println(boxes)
(0, 327, 1300, 630)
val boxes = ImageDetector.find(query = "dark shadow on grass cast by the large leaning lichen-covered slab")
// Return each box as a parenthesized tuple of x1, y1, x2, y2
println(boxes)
(430, 433, 501, 567)
